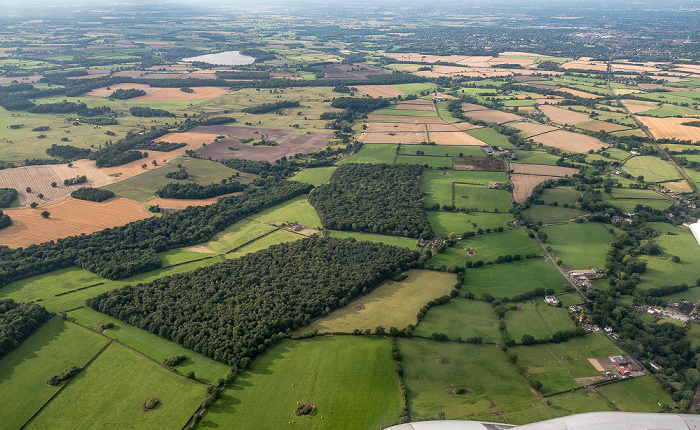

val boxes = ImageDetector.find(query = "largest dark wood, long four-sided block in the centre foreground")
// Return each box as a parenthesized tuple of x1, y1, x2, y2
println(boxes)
(87, 236, 418, 365)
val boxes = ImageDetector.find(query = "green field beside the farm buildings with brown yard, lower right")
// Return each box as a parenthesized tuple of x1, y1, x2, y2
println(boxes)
(509, 332, 621, 394)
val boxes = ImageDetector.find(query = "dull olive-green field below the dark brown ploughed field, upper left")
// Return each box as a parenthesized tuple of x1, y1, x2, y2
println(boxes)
(103, 157, 249, 202)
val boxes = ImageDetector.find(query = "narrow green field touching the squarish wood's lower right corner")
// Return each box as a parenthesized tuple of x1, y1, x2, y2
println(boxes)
(428, 211, 514, 236)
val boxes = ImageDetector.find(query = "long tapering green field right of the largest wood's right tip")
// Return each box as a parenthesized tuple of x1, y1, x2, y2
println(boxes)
(426, 229, 541, 268)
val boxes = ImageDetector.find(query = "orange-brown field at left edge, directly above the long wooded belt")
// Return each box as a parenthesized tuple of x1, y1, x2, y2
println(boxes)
(0, 198, 153, 248)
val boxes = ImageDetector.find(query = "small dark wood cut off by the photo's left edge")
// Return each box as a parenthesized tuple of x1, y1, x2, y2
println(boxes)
(0, 299, 51, 358)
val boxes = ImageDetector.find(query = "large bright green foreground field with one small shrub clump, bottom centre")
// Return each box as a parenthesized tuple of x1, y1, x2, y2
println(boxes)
(201, 336, 401, 429)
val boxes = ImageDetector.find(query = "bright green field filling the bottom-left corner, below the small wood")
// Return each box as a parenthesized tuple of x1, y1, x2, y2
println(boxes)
(0, 317, 108, 429)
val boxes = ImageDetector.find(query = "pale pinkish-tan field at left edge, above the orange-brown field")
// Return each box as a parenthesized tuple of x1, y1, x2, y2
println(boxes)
(0, 160, 112, 206)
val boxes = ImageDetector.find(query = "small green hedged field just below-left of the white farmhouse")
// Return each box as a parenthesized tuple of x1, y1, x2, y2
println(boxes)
(506, 299, 574, 342)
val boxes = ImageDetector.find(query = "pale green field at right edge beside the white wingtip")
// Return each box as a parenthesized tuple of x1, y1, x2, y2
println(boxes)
(638, 223, 700, 290)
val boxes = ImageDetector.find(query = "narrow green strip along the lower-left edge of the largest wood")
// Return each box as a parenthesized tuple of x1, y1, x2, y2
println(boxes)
(68, 308, 230, 385)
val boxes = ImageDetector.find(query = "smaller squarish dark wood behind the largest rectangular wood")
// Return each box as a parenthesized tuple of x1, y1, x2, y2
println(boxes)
(309, 164, 433, 239)
